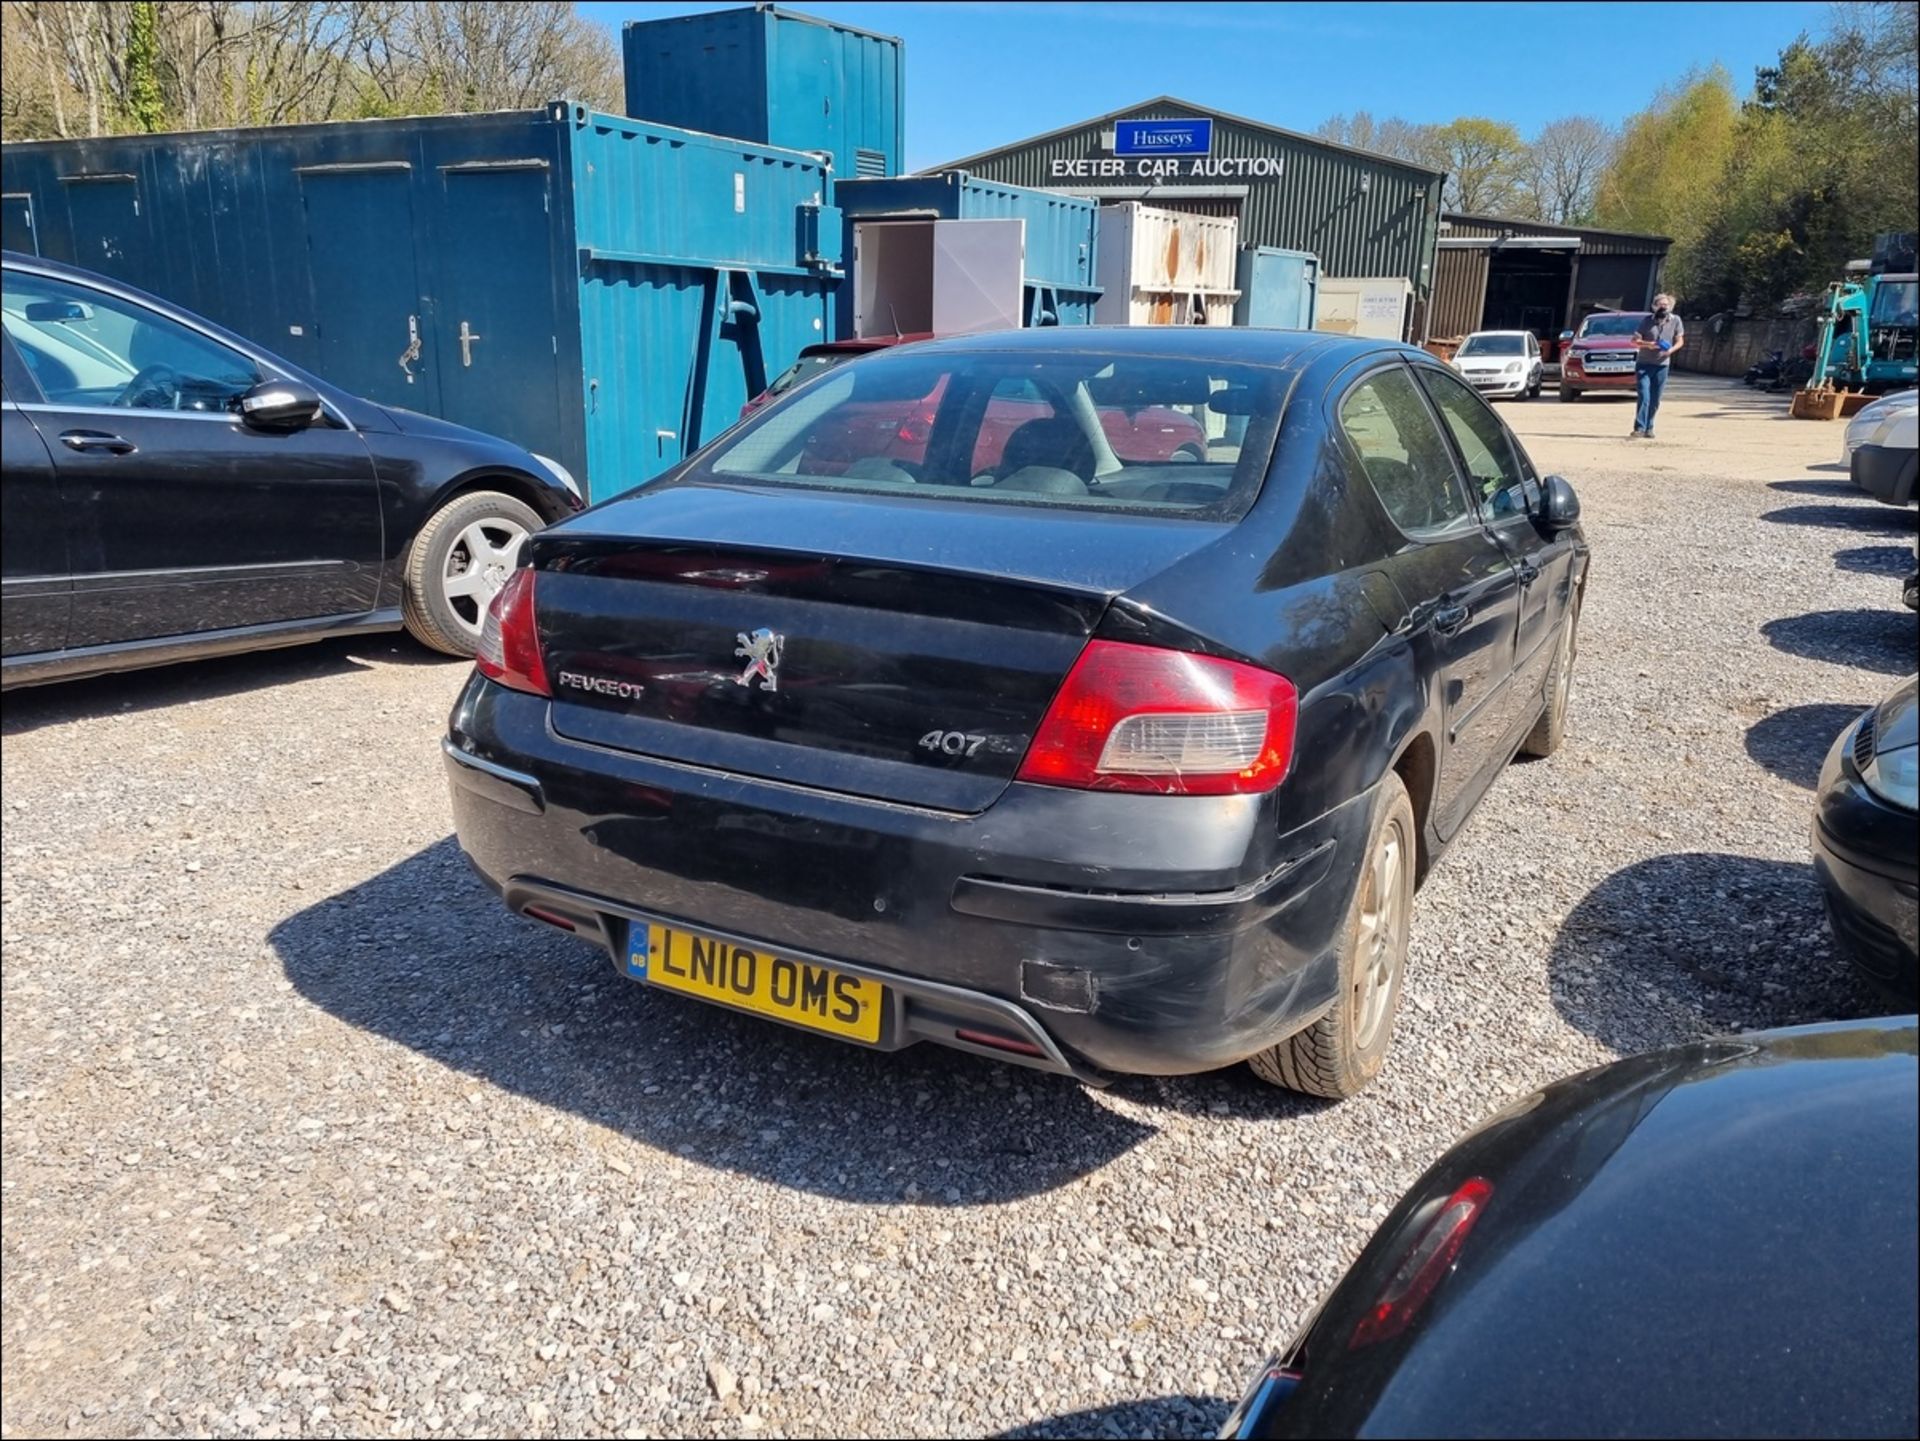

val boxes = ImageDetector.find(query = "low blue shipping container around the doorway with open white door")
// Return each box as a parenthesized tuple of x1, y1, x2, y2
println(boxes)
(833, 171, 1100, 336)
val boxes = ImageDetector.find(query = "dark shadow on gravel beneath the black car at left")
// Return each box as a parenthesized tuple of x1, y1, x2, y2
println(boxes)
(0, 635, 458, 735)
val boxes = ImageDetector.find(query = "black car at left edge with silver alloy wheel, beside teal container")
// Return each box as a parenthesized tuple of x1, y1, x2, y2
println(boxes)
(0, 253, 580, 687)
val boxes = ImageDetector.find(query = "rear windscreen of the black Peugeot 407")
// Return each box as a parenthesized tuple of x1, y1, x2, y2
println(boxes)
(691, 349, 1292, 520)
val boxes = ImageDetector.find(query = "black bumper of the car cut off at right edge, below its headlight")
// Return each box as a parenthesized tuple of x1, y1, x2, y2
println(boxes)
(1812, 723, 1920, 1002)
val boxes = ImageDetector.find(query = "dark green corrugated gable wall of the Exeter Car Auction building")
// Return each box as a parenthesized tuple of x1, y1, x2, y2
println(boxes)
(929, 96, 1444, 294)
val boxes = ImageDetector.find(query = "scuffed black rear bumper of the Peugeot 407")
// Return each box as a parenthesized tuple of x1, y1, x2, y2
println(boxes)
(445, 677, 1371, 1080)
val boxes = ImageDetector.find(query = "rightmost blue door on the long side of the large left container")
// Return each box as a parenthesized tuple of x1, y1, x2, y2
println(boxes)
(434, 161, 561, 455)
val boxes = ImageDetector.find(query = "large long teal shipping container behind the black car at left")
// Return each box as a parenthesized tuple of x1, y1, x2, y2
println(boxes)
(0, 102, 841, 499)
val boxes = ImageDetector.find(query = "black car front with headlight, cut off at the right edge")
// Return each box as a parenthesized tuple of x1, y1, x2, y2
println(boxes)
(1812, 679, 1920, 1005)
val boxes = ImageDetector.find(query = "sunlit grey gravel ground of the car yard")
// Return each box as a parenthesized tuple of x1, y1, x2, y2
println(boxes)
(0, 378, 1914, 1435)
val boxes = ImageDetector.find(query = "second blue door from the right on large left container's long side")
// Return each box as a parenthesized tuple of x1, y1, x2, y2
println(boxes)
(288, 161, 438, 411)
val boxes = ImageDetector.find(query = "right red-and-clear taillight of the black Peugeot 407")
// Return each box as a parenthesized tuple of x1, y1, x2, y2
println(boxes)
(1018, 641, 1300, 796)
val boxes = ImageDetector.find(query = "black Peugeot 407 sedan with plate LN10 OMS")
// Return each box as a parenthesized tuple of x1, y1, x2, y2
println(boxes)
(445, 328, 1586, 1096)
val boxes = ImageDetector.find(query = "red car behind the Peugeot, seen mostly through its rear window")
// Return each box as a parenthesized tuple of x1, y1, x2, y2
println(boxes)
(741, 334, 1208, 476)
